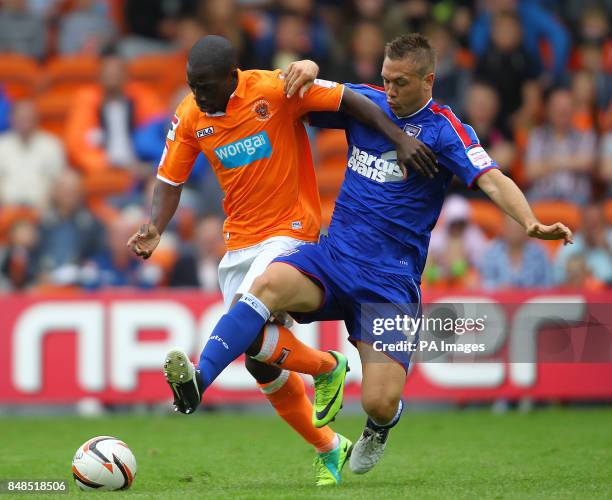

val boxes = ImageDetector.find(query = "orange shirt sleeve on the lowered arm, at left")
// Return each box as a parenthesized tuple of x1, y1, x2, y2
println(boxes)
(157, 94, 200, 186)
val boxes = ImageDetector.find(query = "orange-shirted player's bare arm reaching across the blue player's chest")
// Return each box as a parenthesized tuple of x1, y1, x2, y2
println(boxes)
(339, 87, 438, 178)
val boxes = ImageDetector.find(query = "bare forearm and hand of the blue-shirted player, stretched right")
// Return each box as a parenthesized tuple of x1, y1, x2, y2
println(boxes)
(476, 169, 574, 245)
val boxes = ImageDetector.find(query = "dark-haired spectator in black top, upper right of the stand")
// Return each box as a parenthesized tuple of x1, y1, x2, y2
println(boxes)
(474, 12, 537, 129)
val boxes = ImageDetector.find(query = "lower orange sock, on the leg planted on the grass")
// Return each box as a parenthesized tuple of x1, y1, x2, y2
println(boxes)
(259, 370, 338, 453)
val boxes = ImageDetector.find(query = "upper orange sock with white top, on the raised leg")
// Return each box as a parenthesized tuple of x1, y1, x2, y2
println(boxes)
(253, 323, 336, 375)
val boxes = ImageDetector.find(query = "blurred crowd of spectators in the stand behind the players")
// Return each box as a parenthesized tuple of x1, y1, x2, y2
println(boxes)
(0, 0, 612, 291)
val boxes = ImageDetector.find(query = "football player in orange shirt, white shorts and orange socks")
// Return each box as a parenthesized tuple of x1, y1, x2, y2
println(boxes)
(128, 36, 437, 485)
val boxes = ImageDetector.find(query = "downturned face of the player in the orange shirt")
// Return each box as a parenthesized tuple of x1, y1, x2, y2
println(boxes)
(187, 66, 237, 114)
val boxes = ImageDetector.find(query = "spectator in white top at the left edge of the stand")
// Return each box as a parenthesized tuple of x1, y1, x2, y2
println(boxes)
(0, 100, 66, 210)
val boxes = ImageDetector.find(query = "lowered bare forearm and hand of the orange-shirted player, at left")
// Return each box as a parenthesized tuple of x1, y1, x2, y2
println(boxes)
(127, 179, 183, 259)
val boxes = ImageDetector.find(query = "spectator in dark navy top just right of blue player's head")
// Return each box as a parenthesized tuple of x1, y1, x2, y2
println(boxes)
(427, 24, 470, 114)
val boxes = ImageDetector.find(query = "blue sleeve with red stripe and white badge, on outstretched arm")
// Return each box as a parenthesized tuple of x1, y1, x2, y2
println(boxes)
(437, 115, 499, 187)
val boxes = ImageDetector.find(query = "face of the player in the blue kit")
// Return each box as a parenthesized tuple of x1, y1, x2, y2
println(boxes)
(381, 57, 434, 116)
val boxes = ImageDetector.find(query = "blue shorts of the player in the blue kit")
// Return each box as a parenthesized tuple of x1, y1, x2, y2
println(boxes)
(273, 237, 421, 370)
